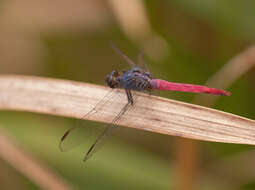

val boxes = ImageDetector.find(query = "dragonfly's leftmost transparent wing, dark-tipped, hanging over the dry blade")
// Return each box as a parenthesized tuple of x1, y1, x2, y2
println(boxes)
(59, 89, 121, 151)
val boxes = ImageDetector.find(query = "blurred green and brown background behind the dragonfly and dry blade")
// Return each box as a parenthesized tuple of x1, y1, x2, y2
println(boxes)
(0, 0, 255, 190)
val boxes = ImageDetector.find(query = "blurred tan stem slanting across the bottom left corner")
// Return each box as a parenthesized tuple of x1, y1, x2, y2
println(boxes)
(0, 129, 72, 190)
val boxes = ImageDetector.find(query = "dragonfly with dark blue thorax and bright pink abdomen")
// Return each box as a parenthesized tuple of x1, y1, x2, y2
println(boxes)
(59, 43, 231, 161)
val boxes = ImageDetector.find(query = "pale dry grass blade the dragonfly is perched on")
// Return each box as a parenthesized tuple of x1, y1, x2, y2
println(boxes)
(0, 75, 255, 145)
